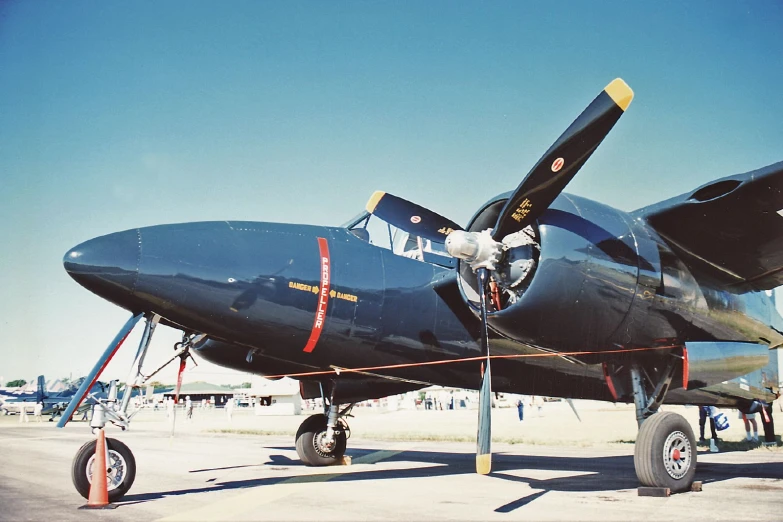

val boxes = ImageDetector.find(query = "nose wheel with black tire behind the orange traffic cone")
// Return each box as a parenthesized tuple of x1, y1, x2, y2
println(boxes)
(71, 437, 136, 502)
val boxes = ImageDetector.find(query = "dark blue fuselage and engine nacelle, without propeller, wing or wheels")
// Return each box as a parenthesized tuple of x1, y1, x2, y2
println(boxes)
(64, 194, 783, 402)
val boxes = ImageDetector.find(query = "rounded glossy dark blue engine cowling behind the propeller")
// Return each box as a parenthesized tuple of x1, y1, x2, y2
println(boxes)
(459, 195, 648, 351)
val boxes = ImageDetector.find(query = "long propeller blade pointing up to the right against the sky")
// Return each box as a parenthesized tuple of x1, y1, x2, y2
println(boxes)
(492, 78, 633, 241)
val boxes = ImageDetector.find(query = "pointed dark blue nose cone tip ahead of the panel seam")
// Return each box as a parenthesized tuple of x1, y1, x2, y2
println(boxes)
(63, 229, 141, 302)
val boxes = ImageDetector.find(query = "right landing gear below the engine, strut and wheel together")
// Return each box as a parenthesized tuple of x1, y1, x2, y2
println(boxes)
(630, 358, 696, 493)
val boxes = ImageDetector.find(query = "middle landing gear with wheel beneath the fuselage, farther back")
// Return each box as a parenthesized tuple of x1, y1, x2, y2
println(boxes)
(296, 385, 353, 466)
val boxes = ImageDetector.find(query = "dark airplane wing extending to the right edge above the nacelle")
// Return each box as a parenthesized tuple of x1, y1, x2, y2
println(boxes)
(634, 162, 783, 290)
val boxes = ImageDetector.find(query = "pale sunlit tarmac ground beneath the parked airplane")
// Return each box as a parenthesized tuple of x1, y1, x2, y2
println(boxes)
(0, 412, 783, 521)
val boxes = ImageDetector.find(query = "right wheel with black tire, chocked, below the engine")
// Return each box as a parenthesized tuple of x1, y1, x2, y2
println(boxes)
(633, 411, 697, 493)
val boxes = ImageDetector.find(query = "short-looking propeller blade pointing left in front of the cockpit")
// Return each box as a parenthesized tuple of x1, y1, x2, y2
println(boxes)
(366, 190, 462, 243)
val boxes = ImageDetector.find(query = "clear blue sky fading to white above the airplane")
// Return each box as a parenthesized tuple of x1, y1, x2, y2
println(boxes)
(0, 0, 783, 382)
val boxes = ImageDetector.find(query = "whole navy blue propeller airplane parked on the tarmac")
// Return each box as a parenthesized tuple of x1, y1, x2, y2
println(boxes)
(61, 79, 783, 500)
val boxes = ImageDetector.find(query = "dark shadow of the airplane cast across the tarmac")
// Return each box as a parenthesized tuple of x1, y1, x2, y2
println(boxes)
(119, 447, 783, 513)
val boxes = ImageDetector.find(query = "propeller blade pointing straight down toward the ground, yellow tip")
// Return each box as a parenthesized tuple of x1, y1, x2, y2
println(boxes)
(476, 268, 492, 475)
